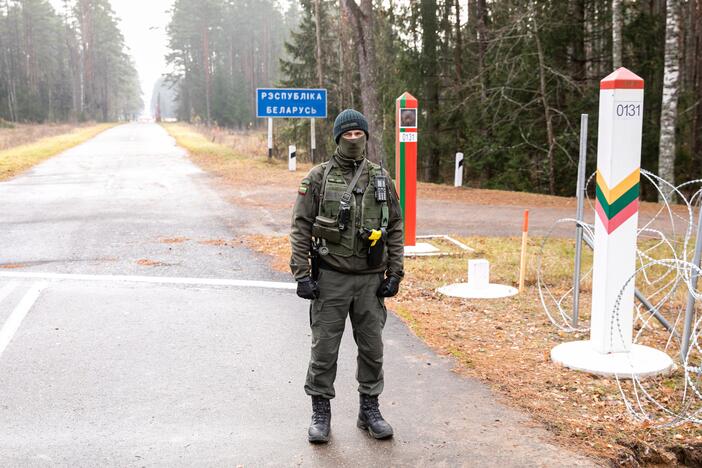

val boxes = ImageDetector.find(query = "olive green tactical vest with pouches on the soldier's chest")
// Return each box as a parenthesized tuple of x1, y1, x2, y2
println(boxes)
(312, 159, 388, 257)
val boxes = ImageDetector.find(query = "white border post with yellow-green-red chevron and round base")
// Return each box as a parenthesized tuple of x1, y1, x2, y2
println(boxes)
(551, 68, 673, 377)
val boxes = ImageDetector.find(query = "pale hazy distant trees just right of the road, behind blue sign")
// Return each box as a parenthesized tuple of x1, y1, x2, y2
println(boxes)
(166, 0, 295, 128)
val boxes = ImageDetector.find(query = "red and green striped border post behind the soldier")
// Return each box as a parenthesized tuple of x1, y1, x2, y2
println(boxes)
(395, 93, 418, 246)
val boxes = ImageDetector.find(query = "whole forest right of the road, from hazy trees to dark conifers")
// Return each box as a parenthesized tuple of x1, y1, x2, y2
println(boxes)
(169, 0, 702, 197)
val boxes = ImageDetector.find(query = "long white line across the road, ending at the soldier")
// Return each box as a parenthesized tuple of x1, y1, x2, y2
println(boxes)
(0, 271, 297, 290)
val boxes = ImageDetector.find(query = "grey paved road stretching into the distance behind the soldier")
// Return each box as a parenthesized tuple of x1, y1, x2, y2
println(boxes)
(0, 124, 600, 467)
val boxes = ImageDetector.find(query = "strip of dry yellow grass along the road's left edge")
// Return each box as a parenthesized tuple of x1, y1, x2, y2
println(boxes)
(0, 123, 116, 180)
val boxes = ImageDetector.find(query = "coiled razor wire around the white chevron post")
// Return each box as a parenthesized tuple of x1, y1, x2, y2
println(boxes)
(536, 169, 702, 427)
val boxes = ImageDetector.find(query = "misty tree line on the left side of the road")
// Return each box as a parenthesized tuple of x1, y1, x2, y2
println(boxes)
(0, 0, 143, 122)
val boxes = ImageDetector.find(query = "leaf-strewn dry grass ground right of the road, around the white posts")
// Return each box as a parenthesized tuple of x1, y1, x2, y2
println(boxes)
(245, 236, 702, 465)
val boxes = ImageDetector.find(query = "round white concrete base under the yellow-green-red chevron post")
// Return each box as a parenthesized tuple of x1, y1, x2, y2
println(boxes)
(551, 340, 675, 379)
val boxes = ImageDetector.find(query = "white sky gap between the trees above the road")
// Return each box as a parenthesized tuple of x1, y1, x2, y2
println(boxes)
(51, 0, 174, 113)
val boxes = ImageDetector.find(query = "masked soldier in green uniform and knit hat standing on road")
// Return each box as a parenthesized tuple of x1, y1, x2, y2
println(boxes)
(290, 109, 404, 442)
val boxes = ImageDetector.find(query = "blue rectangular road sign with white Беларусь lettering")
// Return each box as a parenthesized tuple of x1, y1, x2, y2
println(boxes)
(256, 88, 327, 119)
